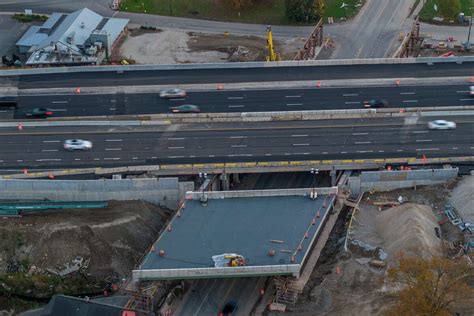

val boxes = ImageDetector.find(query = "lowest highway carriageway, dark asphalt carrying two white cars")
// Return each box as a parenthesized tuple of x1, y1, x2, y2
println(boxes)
(0, 116, 474, 169)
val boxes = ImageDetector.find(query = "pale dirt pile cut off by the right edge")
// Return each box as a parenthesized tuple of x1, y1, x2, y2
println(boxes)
(449, 176, 474, 224)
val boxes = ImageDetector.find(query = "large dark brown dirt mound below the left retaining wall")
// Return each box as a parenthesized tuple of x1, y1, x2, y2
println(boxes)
(0, 201, 168, 277)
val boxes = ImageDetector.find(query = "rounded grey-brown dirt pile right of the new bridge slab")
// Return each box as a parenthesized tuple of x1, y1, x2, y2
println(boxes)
(376, 203, 441, 258)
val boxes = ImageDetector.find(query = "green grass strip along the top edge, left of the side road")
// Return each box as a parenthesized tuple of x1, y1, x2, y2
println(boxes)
(120, 0, 365, 25)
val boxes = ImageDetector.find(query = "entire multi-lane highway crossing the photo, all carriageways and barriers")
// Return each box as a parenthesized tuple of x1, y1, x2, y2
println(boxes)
(0, 57, 474, 174)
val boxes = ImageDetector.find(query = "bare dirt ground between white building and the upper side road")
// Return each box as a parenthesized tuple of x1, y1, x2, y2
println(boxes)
(119, 29, 305, 64)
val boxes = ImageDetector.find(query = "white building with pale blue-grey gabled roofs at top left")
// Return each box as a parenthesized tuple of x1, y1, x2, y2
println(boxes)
(16, 8, 129, 66)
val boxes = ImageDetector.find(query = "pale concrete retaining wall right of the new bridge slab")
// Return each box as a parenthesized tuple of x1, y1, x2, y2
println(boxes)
(349, 168, 459, 194)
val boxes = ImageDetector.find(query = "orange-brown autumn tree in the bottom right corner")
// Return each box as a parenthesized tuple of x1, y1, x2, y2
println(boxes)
(387, 255, 474, 316)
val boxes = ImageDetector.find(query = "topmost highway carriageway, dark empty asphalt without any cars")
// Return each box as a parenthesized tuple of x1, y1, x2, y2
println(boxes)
(12, 62, 474, 89)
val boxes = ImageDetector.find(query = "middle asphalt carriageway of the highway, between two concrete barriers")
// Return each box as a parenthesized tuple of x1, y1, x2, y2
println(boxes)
(9, 85, 474, 119)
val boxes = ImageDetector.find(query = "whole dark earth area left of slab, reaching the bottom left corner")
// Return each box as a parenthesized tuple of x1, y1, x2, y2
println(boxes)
(0, 201, 170, 315)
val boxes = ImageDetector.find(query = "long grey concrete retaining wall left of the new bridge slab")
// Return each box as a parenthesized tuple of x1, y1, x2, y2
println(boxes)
(0, 178, 194, 209)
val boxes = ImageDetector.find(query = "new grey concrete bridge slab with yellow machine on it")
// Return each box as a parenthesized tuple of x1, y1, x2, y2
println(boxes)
(136, 194, 334, 279)
